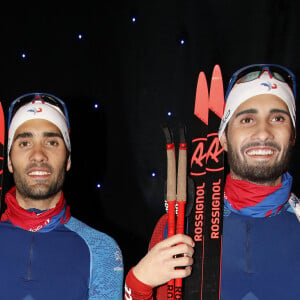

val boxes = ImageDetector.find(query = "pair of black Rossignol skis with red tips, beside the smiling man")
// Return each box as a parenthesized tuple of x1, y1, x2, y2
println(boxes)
(183, 65, 225, 300)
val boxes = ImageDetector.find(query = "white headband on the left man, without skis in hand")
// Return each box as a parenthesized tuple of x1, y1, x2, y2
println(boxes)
(7, 101, 71, 155)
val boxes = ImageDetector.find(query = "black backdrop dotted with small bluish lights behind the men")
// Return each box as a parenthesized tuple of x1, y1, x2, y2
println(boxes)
(0, 0, 300, 272)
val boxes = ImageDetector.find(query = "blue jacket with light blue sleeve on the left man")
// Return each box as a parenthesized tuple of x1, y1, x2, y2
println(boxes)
(0, 217, 123, 300)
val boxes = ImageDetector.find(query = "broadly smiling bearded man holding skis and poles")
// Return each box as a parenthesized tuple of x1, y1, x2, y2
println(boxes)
(125, 65, 300, 300)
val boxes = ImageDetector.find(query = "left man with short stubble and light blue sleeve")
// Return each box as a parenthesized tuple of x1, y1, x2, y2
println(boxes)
(0, 93, 123, 300)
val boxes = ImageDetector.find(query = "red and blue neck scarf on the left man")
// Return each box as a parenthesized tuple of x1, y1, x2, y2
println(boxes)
(1, 187, 71, 232)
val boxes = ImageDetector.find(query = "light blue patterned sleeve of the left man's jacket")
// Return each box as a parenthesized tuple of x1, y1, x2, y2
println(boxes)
(67, 218, 124, 300)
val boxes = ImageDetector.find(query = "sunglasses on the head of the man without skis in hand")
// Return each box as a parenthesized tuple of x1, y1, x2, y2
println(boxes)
(8, 93, 70, 130)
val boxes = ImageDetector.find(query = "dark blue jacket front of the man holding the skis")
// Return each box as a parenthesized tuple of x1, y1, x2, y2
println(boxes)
(221, 204, 300, 300)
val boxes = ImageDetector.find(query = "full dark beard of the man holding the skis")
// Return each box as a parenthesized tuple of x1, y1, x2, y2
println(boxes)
(227, 138, 293, 185)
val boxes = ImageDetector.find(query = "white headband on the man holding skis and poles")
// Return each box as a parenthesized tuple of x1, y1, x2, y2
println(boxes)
(219, 73, 296, 138)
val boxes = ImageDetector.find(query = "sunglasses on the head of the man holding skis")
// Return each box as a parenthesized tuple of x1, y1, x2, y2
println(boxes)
(225, 64, 296, 99)
